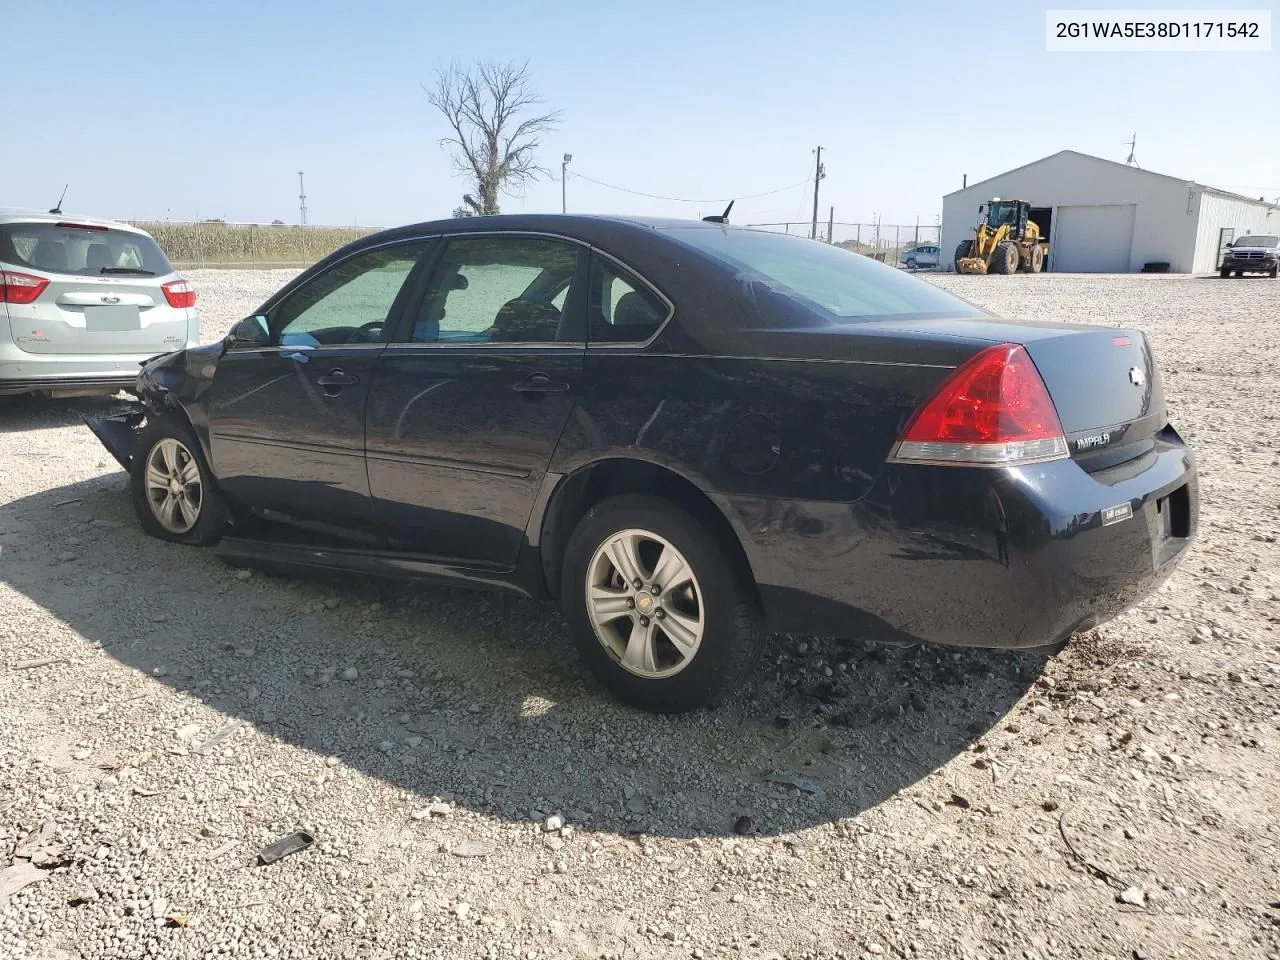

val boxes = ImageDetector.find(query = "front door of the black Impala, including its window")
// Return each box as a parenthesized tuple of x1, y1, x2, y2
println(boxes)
(209, 241, 428, 544)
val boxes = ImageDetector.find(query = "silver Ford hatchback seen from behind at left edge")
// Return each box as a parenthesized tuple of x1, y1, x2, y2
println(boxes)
(0, 210, 200, 396)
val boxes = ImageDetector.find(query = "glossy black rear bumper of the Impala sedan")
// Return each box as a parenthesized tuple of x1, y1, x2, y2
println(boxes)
(735, 431, 1198, 649)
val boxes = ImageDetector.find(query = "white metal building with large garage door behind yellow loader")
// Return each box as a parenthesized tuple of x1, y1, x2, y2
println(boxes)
(942, 150, 1280, 274)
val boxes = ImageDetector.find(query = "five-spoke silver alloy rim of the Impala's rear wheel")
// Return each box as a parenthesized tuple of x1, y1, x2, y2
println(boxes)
(586, 529, 705, 680)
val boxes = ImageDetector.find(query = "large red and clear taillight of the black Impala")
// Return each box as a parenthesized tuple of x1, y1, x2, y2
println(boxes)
(891, 343, 1068, 466)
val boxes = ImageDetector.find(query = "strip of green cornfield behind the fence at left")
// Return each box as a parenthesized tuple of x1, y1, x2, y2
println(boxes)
(134, 221, 374, 266)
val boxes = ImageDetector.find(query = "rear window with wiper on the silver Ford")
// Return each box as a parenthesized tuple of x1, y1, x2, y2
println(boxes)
(0, 223, 173, 276)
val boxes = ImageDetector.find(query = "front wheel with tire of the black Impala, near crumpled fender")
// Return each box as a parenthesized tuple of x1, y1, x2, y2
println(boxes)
(129, 417, 221, 547)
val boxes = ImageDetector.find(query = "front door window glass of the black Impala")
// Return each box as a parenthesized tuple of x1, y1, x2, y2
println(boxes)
(271, 243, 428, 347)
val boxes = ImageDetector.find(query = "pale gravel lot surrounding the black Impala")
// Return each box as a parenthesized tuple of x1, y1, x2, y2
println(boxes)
(0, 271, 1280, 960)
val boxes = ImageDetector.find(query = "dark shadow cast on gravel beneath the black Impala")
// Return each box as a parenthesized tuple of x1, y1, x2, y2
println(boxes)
(0, 471, 1044, 837)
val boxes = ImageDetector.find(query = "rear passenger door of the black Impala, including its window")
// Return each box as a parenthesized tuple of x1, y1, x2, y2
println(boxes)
(366, 234, 586, 568)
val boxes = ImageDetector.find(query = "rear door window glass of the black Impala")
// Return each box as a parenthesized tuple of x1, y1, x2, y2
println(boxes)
(410, 237, 579, 343)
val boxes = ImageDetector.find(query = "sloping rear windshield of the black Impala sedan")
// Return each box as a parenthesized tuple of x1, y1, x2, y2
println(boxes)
(671, 227, 983, 321)
